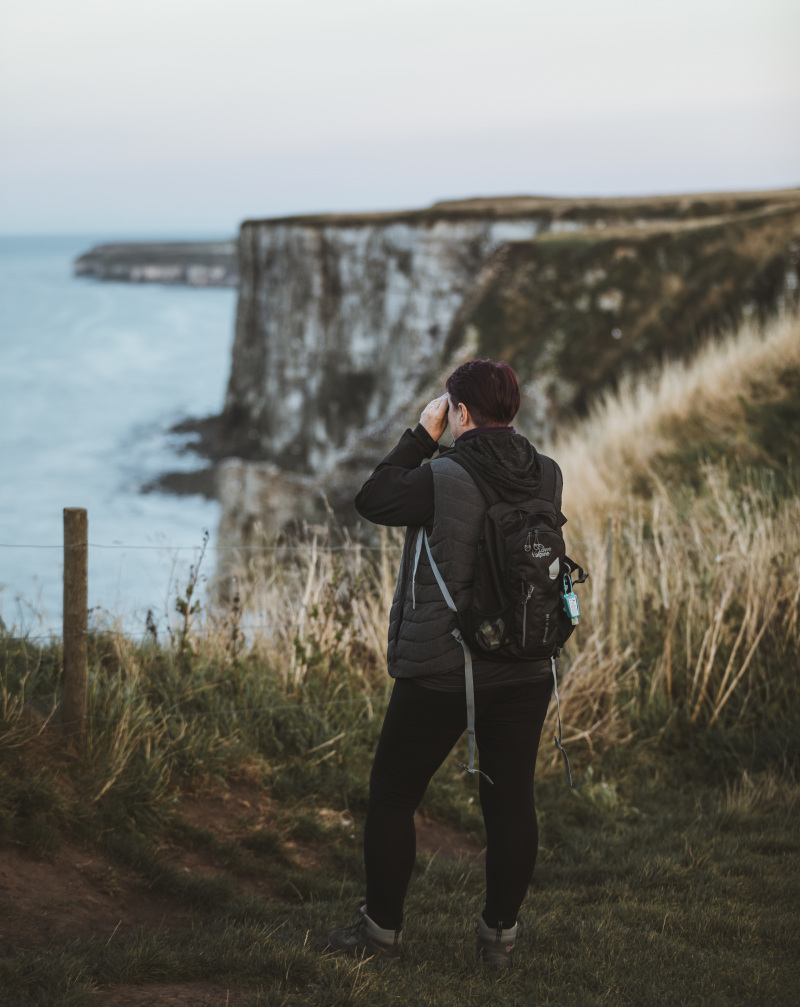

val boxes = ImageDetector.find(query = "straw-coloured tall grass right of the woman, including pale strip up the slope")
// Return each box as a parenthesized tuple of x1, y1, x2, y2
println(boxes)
(536, 315, 800, 769)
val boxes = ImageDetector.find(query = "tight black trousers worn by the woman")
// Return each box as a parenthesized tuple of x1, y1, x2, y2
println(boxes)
(364, 679, 552, 929)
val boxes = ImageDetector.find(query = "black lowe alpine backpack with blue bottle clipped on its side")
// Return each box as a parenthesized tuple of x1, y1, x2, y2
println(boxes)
(449, 452, 586, 662)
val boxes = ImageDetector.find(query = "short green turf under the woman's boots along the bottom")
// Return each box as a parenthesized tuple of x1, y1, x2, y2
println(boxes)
(0, 752, 800, 1007)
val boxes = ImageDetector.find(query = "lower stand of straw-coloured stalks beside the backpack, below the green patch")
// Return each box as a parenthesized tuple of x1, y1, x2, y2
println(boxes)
(544, 470, 800, 757)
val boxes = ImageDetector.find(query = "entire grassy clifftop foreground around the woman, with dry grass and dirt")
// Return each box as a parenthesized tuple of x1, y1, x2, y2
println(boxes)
(0, 310, 800, 1007)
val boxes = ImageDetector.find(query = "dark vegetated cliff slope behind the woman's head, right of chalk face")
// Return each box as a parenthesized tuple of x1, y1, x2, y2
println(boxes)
(447, 202, 800, 433)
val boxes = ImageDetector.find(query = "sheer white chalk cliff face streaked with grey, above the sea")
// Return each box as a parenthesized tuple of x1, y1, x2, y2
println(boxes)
(226, 211, 544, 473)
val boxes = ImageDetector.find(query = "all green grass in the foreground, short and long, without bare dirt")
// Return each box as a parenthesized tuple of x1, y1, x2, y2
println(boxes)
(0, 664, 789, 1007)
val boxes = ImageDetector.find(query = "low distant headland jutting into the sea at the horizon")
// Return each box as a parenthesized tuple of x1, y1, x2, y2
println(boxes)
(73, 239, 239, 287)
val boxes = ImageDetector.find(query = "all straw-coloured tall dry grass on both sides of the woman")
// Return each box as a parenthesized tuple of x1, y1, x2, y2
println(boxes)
(194, 316, 800, 765)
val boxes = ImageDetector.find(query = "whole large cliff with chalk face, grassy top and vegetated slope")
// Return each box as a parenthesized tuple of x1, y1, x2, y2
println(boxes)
(207, 189, 800, 551)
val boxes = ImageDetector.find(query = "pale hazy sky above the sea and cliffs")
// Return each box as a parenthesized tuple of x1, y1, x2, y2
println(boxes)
(0, 0, 800, 235)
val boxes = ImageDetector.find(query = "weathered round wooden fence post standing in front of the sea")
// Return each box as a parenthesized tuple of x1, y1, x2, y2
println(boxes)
(61, 507, 89, 736)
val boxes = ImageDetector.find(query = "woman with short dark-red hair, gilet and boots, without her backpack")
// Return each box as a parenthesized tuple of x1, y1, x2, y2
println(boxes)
(328, 359, 564, 967)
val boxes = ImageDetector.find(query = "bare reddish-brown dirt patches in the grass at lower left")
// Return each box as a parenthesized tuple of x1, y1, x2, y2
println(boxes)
(0, 784, 483, 1007)
